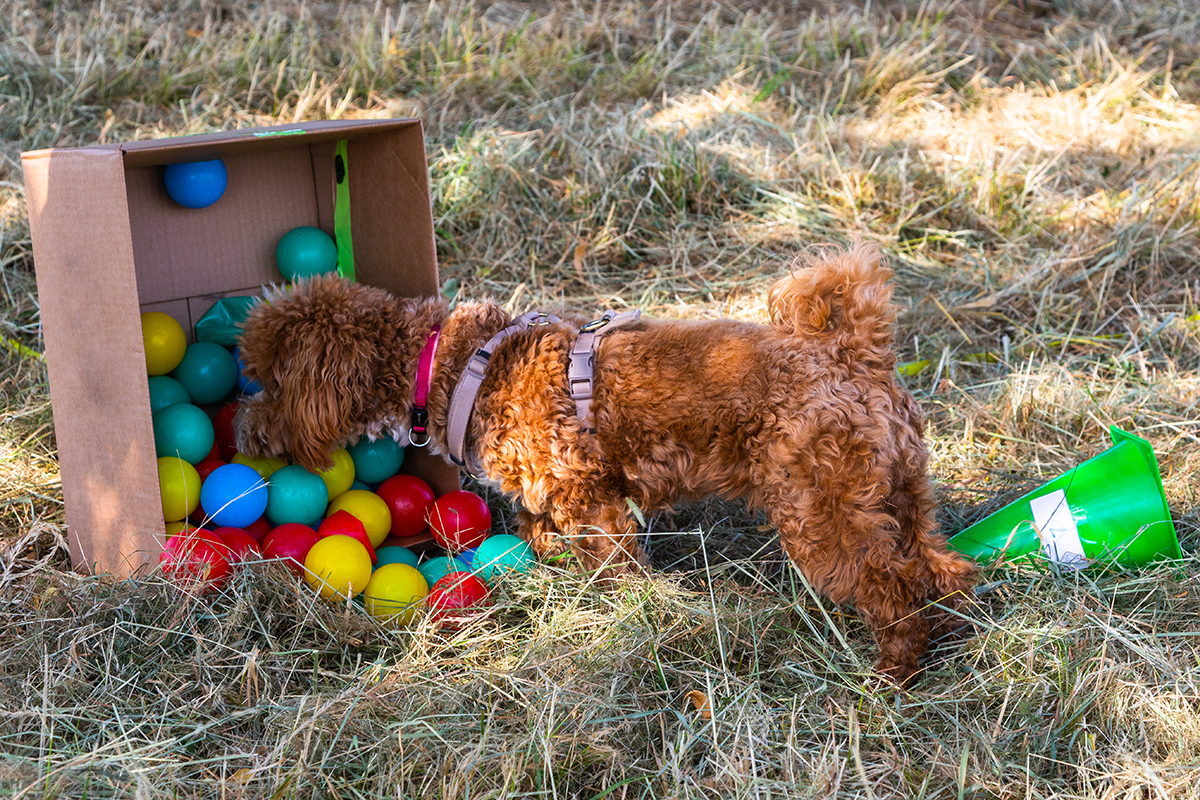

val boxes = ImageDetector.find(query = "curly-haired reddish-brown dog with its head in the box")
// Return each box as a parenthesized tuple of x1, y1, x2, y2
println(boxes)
(238, 246, 974, 681)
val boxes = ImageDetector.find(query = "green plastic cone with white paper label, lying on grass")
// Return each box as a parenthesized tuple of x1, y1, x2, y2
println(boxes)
(949, 426, 1182, 567)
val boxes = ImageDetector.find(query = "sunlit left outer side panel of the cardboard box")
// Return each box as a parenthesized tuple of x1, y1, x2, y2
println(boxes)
(23, 150, 164, 575)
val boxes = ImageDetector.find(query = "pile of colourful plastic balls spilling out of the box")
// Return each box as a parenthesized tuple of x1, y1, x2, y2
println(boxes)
(142, 312, 534, 624)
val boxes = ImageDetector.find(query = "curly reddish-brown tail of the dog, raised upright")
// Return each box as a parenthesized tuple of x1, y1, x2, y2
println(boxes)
(767, 243, 895, 362)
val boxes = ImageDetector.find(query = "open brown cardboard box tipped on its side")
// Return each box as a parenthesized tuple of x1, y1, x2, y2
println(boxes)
(22, 120, 458, 576)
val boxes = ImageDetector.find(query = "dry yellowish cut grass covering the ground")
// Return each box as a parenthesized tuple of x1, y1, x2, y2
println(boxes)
(0, 0, 1200, 800)
